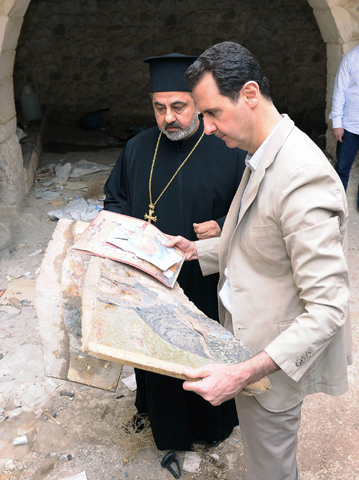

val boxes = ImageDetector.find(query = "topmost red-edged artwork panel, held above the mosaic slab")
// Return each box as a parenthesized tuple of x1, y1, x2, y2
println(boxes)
(72, 210, 185, 288)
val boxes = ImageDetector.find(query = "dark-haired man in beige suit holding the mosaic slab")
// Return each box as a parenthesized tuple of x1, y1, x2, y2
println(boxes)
(169, 42, 351, 480)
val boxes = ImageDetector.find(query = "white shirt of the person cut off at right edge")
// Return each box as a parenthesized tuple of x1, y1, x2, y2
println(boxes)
(329, 45, 359, 135)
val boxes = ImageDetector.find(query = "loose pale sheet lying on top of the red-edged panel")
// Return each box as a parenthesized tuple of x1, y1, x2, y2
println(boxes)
(107, 225, 181, 271)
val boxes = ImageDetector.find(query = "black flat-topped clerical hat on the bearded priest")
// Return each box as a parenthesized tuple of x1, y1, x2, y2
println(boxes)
(144, 53, 197, 93)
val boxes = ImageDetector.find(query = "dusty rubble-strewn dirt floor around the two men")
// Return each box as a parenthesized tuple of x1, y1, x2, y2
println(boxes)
(0, 127, 359, 480)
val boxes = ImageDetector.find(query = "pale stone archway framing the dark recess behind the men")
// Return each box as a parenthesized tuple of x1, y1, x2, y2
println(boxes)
(0, 0, 359, 218)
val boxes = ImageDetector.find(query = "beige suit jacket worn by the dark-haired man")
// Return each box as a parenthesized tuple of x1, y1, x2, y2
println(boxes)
(196, 116, 351, 412)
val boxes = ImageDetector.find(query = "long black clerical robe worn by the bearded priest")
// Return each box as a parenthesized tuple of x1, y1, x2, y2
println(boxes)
(104, 122, 245, 450)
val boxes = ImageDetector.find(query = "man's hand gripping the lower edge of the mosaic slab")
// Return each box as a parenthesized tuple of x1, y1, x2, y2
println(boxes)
(183, 352, 279, 406)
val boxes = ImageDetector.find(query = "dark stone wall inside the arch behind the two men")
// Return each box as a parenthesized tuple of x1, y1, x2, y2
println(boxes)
(14, 0, 326, 129)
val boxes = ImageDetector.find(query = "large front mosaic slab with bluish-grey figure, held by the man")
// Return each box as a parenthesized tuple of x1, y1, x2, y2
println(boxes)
(82, 257, 270, 394)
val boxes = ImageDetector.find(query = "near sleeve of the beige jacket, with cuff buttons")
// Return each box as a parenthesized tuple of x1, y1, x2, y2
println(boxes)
(265, 166, 349, 381)
